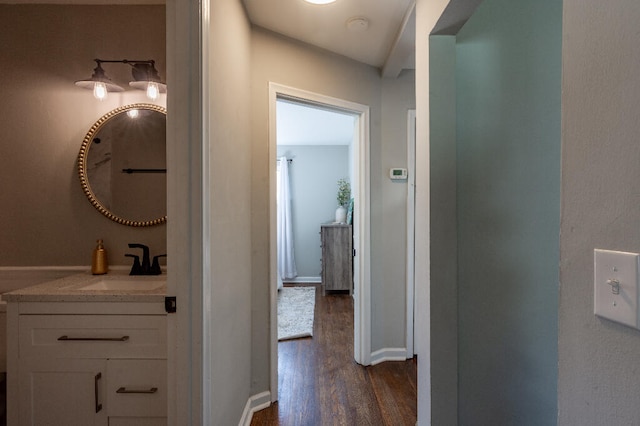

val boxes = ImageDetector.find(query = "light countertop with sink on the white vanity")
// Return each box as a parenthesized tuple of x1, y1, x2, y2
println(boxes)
(2, 271, 167, 303)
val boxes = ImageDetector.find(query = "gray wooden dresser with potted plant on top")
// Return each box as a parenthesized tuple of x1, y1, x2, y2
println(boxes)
(320, 223, 353, 294)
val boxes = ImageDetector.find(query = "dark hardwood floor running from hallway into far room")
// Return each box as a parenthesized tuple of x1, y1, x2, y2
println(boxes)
(251, 287, 417, 426)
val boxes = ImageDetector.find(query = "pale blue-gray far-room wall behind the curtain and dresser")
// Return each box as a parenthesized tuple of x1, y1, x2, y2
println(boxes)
(278, 145, 349, 282)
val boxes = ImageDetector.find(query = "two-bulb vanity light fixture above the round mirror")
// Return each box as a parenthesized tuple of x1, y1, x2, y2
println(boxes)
(76, 59, 167, 100)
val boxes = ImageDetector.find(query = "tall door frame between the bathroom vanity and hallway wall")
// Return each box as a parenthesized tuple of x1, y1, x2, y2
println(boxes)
(166, 0, 205, 425)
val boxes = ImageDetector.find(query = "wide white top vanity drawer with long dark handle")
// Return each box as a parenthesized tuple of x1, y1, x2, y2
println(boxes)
(19, 315, 167, 358)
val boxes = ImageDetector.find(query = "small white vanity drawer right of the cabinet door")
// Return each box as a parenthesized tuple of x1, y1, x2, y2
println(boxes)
(107, 359, 167, 421)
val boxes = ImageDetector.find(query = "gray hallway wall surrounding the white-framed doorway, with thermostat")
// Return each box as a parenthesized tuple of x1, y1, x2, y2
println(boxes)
(250, 27, 415, 393)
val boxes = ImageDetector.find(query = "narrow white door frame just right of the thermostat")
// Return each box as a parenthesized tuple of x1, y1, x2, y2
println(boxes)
(406, 109, 417, 359)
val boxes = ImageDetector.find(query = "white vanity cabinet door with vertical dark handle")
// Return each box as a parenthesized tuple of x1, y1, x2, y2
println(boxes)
(19, 358, 107, 426)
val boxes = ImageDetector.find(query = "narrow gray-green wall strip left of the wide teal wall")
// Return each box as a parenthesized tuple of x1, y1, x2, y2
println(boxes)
(429, 36, 458, 425)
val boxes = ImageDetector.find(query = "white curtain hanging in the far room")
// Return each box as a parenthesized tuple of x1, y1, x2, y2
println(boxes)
(276, 157, 298, 288)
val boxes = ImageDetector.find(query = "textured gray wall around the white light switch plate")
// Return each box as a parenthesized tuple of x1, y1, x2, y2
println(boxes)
(558, 0, 640, 426)
